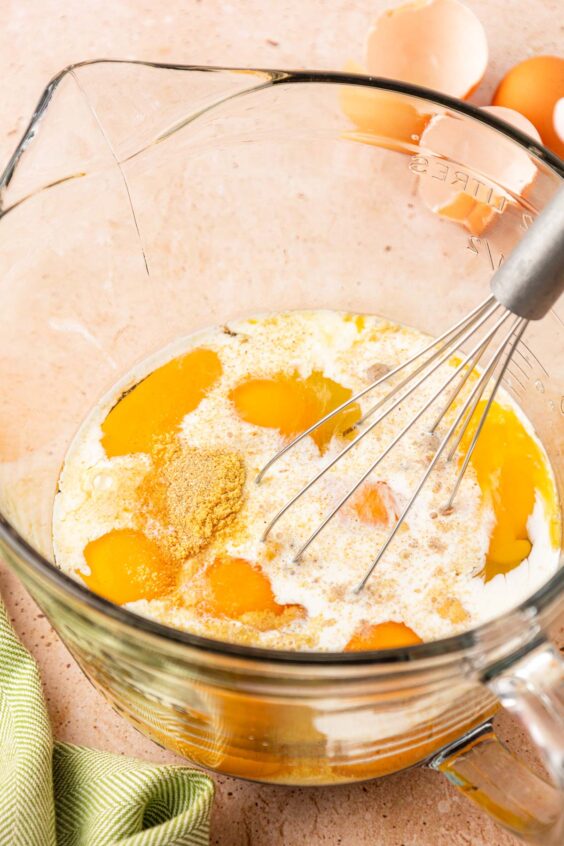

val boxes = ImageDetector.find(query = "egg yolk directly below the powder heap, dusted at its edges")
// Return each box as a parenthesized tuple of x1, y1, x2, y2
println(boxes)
(204, 555, 288, 620)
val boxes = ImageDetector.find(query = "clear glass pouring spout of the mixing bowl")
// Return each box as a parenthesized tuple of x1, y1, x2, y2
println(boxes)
(0, 59, 274, 222)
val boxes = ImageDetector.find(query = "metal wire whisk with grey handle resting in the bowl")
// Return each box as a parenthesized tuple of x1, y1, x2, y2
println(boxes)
(256, 188, 564, 593)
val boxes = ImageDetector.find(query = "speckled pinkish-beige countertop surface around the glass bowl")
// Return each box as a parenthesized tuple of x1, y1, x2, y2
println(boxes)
(0, 0, 564, 846)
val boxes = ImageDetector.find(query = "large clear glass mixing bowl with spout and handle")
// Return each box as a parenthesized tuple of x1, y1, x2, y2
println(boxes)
(0, 61, 564, 844)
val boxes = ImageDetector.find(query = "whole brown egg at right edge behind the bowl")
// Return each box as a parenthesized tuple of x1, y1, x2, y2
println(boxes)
(493, 56, 564, 157)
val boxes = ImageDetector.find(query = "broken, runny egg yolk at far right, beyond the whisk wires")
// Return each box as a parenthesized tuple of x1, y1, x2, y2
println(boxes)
(461, 401, 560, 582)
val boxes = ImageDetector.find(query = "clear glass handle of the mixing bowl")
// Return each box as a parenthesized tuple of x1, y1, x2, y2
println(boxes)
(429, 643, 564, 846)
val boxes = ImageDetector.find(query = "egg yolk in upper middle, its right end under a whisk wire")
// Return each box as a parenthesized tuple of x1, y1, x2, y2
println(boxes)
(230, 371, 360, 452)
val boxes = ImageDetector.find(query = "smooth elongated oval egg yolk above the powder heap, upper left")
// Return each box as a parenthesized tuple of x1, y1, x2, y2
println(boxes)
(101, 349, 222, 458)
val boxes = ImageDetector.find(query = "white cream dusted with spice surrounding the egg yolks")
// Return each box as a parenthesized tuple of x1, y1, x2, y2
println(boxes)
(53, 311, 558, 651)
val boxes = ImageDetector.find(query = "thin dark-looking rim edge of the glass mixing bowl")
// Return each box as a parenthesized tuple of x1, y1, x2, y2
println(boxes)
(0, 58, 564, 667)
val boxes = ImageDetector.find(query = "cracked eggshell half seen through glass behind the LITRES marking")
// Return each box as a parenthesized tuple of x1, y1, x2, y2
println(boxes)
(418, 106, 540, 235)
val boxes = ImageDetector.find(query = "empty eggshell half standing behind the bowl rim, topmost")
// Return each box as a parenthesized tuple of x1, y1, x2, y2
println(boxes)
(366, 0, 488, 97)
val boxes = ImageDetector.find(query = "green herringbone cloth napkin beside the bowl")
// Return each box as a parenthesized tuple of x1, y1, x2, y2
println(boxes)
(0, 602, 213, 846)
